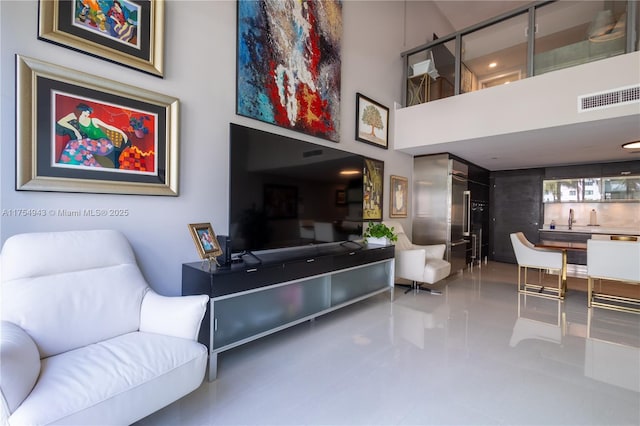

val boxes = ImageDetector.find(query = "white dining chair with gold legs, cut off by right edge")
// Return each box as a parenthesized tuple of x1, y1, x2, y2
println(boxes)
(587, 239, 640, 313)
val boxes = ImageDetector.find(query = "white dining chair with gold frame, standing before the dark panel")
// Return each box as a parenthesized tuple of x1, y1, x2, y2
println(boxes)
(511, 232, 567, 299)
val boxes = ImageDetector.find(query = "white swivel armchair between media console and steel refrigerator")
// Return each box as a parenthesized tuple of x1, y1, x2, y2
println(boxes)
(384, 221, 451, 293)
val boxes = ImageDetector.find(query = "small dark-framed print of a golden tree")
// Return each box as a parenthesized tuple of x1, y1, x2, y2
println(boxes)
(356, 93, 389, 149)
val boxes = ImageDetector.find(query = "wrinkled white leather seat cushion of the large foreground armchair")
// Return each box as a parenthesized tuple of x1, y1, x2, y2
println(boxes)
(11, 332, 207, 425)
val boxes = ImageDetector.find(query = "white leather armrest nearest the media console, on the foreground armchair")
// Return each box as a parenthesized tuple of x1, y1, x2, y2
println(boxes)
(140, 289, 209, 340)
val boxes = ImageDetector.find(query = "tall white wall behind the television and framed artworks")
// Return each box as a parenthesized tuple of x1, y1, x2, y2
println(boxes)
(0, 0, 432, 295)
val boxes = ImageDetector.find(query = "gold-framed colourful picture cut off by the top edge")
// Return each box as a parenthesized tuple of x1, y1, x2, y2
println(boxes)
(38, 0, 164, 77)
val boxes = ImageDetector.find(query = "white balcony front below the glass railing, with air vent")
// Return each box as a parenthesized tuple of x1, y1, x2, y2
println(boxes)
(395, 52, 640, 149)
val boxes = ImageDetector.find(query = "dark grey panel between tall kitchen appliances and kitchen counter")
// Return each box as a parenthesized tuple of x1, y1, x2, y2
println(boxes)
(489, 168, 545, 263)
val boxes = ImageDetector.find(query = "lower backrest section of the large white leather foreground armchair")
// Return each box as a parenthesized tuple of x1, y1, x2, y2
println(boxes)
(2, 264, 149, 358)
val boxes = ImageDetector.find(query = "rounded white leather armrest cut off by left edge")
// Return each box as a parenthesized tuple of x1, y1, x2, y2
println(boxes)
(0, 321, 40, 413)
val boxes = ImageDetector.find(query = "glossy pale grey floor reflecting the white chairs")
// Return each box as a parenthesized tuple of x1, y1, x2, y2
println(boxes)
(132, 263, 640, 425)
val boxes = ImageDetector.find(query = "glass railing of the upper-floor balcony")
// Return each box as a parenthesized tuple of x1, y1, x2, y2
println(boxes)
(402, 0, 638, 106)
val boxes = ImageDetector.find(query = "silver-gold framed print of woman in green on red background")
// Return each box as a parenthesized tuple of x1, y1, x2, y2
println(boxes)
(16, 55, 179, 196)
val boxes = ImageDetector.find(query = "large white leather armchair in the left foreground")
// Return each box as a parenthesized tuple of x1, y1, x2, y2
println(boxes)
(0, 230, 208, 425)
